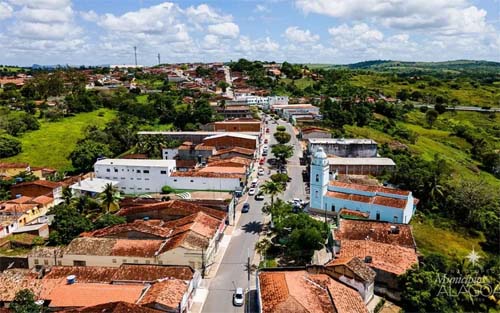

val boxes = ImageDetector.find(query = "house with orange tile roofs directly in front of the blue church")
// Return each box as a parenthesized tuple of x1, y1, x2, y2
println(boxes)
(327, 219, 418, 296)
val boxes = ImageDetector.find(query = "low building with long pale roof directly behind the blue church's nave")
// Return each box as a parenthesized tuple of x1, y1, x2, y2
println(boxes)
(328, 158, 396, 176)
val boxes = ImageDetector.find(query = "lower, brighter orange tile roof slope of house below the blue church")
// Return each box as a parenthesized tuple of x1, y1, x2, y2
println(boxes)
(339, 240, 418, 275)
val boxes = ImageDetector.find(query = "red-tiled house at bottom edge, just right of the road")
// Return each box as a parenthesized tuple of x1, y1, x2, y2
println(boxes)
(257, 268, 368, 313)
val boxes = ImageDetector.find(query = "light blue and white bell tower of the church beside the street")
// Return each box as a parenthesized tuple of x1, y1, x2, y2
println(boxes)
(310, 147, 330, 210)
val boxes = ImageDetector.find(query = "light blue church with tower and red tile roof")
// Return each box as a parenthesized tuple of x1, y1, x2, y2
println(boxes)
(309, 147, 418, 224)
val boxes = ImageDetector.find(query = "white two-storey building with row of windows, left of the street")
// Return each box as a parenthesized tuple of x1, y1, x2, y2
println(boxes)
(94, 159, 175, 194)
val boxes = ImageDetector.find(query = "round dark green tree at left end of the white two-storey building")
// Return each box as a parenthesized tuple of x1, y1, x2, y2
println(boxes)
(69, 140, 112, 172)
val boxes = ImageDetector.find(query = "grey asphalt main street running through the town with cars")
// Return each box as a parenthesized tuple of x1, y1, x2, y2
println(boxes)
(202, 116, 305, 313)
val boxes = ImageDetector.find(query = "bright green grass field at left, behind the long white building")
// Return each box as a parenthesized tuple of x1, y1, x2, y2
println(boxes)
(2, 109, 115, 170)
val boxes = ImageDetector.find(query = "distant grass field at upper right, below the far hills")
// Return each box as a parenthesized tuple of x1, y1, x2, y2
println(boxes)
(350, 74, 500, 107)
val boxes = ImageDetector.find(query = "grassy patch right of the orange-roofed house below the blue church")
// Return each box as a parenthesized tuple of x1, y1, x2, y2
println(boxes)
(411, 219, 484, 258)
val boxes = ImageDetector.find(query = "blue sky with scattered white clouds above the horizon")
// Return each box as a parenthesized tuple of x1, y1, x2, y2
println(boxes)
(0, 0, 500, 65)
